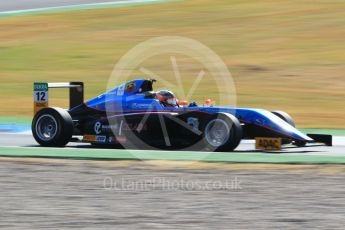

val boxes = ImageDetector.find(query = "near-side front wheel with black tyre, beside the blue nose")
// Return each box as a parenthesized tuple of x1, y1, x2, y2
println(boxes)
(203, 113, 243, 152)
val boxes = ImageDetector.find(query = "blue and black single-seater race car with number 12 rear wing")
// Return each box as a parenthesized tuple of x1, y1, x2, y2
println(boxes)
(32, 79, 332, 151)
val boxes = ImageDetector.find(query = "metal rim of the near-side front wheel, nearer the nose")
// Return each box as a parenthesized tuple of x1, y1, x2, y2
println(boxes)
(205, 119, 230, 147)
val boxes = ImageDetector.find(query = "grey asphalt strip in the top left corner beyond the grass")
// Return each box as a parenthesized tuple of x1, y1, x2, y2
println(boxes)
(0, 0, 142, 12)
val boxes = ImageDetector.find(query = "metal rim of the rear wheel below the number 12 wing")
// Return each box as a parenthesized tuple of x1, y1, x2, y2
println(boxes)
(35, 114, 58, 141)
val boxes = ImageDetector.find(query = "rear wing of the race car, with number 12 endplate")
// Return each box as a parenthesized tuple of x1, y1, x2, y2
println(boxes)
(34, 82, 84, 114)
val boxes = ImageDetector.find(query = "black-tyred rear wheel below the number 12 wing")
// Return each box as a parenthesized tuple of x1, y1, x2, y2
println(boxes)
(31, 107, 73, 147)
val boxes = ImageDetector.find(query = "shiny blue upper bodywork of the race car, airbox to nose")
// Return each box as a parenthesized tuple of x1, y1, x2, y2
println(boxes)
(85, 80, 313, 142)
